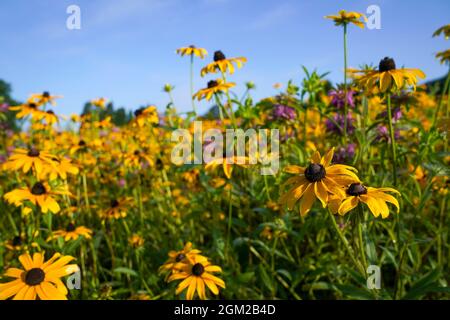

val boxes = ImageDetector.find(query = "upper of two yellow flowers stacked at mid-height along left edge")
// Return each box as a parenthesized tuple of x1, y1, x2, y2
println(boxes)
(5, 148, 53, 175)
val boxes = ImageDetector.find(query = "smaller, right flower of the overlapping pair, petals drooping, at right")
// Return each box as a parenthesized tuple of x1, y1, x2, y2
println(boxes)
(337, 182, 400, 219)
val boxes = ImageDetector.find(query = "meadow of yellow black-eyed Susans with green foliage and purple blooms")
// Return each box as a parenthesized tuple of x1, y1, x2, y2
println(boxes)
(0, 10, 450, 300)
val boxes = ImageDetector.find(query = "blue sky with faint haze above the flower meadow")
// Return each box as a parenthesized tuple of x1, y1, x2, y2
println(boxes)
(0, 0, 450, 114)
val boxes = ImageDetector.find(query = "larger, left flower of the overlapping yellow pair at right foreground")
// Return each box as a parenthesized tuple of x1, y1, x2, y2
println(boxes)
(280, 148, 359, 216)
